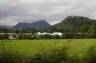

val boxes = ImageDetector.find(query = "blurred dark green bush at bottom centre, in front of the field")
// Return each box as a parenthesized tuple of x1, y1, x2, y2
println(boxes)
(30, 48, 74, 63)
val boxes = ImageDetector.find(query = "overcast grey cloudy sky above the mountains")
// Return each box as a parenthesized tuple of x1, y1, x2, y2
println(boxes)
(0, 0, 96, 25)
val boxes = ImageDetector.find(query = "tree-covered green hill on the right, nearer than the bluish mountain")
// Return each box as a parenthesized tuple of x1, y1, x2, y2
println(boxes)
(45, 16, 96, 33)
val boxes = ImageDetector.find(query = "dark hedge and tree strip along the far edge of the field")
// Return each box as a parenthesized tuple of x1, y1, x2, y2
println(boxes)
(0, 33, 96, 40)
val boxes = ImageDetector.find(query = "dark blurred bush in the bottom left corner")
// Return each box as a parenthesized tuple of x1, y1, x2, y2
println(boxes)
(0, 50, 29, 63)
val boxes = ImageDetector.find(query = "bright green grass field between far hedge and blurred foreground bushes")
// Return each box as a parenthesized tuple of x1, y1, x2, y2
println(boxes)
(0, 39, 96, 56)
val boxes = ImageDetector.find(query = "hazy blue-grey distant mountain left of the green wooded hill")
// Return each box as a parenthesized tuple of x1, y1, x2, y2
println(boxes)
(15, 20, 51, 29)
